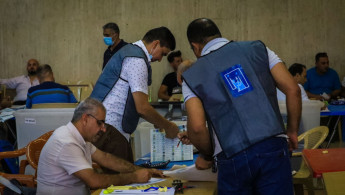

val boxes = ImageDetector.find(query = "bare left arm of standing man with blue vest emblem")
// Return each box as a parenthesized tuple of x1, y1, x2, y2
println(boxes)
(186, 97, 213, 156)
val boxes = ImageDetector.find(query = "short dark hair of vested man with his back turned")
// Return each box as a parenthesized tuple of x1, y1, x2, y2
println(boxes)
(187, 18, 222, 45)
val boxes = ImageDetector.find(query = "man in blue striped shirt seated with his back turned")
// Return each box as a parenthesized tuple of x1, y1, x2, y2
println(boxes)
(26, 64, 77, 108)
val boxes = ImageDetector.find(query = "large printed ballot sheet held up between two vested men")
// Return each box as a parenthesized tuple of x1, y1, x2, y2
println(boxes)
(150, 125, 193, 162)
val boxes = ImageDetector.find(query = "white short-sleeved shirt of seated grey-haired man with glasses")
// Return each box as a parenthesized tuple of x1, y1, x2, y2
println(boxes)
(37, 122, 96, 195)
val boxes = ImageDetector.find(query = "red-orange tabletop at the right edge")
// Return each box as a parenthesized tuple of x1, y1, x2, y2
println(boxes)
(302, 148, 345, 178)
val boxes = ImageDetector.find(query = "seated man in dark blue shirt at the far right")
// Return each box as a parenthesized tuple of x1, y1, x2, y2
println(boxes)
(304, 53, 341, 100)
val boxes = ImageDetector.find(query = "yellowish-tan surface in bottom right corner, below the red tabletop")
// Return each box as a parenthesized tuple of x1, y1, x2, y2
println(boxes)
(323, 171, 345, 195)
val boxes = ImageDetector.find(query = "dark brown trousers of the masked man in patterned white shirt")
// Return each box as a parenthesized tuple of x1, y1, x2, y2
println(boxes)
(93, 124, 134, 174)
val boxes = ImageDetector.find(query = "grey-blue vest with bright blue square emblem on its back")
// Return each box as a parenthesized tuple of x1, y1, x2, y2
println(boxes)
(183, 41, 284, 157)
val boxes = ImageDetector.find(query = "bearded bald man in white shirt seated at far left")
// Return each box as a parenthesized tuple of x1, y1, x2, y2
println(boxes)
(0, 59, 39, 105)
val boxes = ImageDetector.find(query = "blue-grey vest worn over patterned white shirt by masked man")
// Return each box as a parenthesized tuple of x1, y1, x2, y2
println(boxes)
(90, 44, 152, 134)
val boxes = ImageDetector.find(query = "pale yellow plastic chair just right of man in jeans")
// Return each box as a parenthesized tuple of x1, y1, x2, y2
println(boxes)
(292, 126, 329, 195)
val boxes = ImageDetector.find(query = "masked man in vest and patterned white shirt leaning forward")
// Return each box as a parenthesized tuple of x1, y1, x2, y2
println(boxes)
(91, 27, 179, 173)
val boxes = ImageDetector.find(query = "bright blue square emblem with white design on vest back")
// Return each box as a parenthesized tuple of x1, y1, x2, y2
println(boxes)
(220, 64, 253, 97)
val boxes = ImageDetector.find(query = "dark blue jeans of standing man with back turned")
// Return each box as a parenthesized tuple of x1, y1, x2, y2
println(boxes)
(217, 137, 294, 195)
